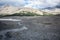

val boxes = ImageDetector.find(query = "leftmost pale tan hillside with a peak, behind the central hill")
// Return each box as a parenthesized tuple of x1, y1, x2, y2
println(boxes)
(0, 5, 19, 15)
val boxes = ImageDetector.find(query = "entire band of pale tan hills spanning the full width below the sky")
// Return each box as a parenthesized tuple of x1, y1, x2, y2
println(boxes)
(0, 5, 60, 15)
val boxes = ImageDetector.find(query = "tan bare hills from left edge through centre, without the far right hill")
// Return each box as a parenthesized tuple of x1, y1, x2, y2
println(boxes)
(0, 5, 43, 15)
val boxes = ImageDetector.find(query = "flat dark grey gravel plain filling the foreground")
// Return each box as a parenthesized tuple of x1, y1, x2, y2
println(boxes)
(0, 16, 60, 40)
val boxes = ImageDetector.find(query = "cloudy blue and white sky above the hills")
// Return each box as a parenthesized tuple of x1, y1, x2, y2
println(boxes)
(0, 0, 60, 9)
